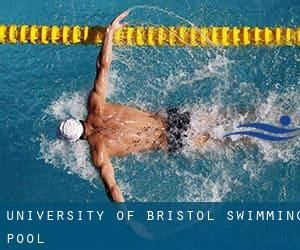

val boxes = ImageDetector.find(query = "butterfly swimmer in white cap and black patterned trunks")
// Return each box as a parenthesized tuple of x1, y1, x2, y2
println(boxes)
(58, 11, 210, 202)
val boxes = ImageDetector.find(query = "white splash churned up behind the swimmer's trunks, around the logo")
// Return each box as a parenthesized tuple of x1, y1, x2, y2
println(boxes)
(180, 90, 300, 162)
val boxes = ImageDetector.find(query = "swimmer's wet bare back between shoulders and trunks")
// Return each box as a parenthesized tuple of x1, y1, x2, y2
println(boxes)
(86, 103, 166, 156)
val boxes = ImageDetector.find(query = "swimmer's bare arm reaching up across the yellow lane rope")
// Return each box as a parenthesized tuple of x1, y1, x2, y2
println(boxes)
(93, 11, 129, 101)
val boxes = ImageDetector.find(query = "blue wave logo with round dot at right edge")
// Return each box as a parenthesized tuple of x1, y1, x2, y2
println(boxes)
(224, 115, 300, 141)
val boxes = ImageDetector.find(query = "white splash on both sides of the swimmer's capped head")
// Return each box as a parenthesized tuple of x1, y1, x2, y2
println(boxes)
(39, 92, 98, 182)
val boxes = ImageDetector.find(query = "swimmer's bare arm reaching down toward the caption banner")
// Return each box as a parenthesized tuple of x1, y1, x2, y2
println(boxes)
(92, 143, 124, 202)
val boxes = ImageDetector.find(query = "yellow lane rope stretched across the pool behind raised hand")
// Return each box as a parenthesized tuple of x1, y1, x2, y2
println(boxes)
(0, 24, 300, 47)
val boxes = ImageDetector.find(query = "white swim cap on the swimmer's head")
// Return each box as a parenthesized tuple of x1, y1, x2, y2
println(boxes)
(59, 118, 84, 142)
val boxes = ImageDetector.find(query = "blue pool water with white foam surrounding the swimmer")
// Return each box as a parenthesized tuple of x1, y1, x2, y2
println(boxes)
(0, 0, 300, 201)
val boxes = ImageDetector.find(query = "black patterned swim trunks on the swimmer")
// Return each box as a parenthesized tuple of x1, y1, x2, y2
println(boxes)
(167, 108, 191, 153)
